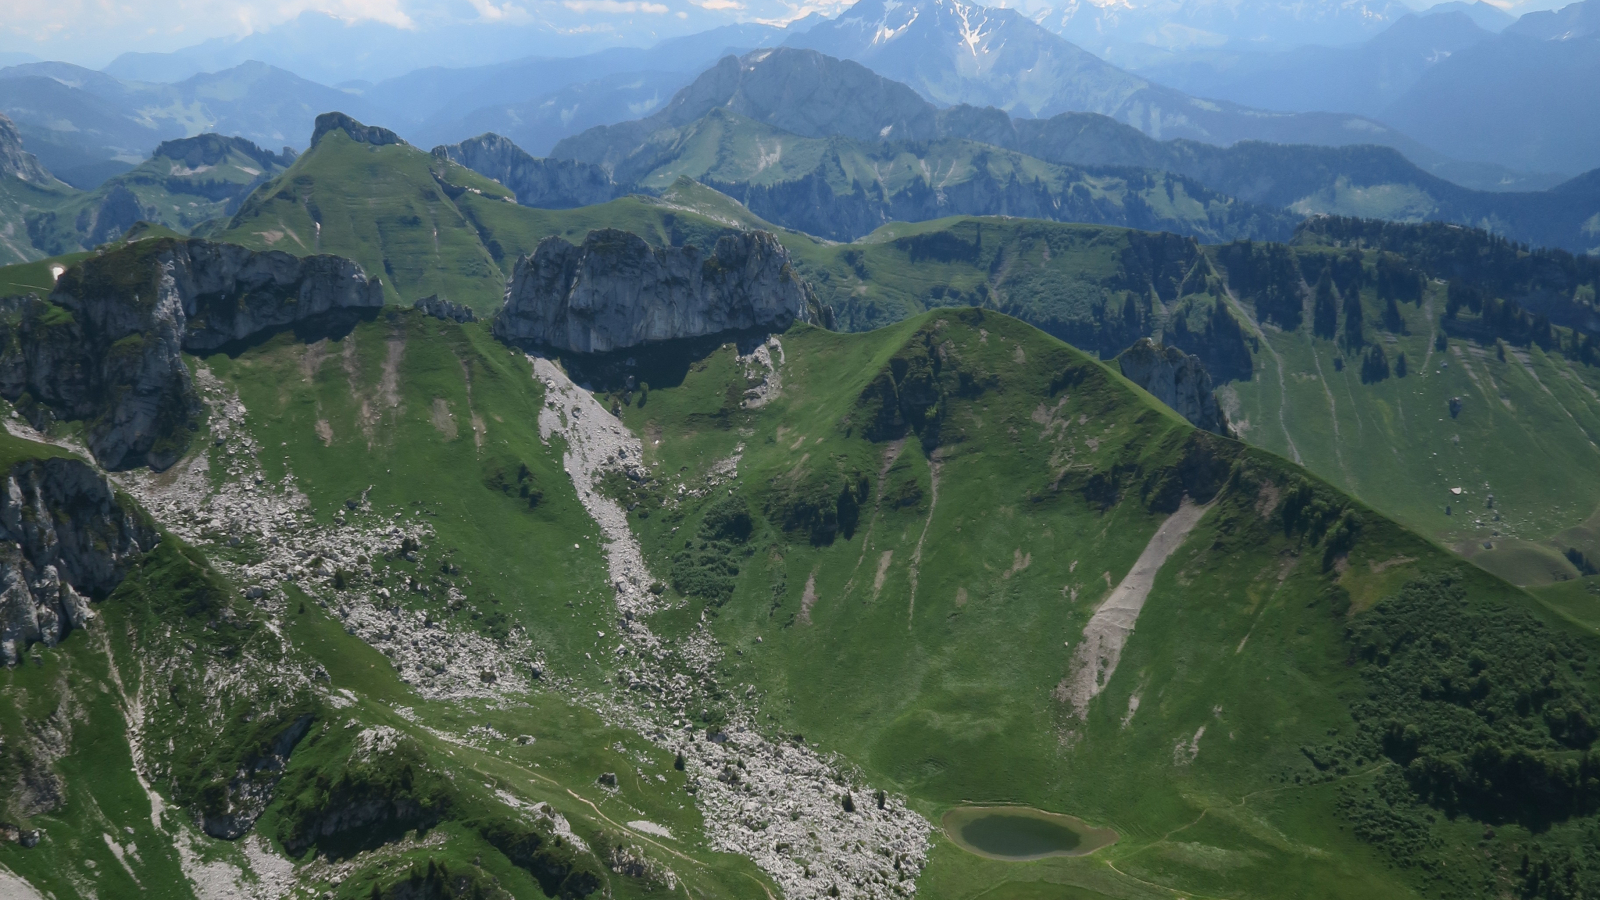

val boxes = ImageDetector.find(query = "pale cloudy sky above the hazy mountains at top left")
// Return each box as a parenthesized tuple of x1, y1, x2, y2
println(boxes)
(0, 0, 1565, 67)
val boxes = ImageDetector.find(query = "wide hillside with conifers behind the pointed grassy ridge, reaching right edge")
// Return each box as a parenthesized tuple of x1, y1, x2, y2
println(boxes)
(790, 219, 1600, 583)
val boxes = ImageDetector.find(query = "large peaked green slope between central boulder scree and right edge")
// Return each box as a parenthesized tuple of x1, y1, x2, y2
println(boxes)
(592, 311, 1594, 898)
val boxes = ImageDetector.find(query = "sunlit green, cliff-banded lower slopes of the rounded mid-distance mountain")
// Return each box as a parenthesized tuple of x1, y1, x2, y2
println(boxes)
(595, 109, 1298, 240)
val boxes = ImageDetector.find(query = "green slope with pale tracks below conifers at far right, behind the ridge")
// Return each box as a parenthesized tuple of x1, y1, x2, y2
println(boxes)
(1213, 230, 1600, 585)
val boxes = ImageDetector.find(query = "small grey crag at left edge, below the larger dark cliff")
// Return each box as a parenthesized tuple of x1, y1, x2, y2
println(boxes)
(0, 458, 158, 666)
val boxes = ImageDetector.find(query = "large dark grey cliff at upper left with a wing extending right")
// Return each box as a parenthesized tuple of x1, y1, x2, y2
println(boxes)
(0, 239, 382, 469)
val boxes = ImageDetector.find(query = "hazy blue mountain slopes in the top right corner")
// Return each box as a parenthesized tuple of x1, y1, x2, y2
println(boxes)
(1138, 0, 1600, 175)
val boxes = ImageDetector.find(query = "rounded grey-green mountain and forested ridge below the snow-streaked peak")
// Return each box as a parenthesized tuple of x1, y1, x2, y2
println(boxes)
(547, 48, 1600, 251)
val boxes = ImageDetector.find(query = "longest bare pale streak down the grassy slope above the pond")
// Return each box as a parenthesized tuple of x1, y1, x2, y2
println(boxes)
(1056, 496, 1210, 719)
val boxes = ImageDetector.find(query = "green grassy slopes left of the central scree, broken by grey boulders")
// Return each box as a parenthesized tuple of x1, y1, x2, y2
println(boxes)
(0, 312, 800, 900)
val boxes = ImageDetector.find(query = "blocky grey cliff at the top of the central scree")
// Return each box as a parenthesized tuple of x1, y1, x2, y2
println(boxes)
(494, 229, 816, 352)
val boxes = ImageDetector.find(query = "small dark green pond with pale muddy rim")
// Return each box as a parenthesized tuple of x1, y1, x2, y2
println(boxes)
(942, 806, 1117, 862)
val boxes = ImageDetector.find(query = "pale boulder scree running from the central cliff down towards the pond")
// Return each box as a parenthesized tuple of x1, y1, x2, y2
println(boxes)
(530, 357, 933, 900)
